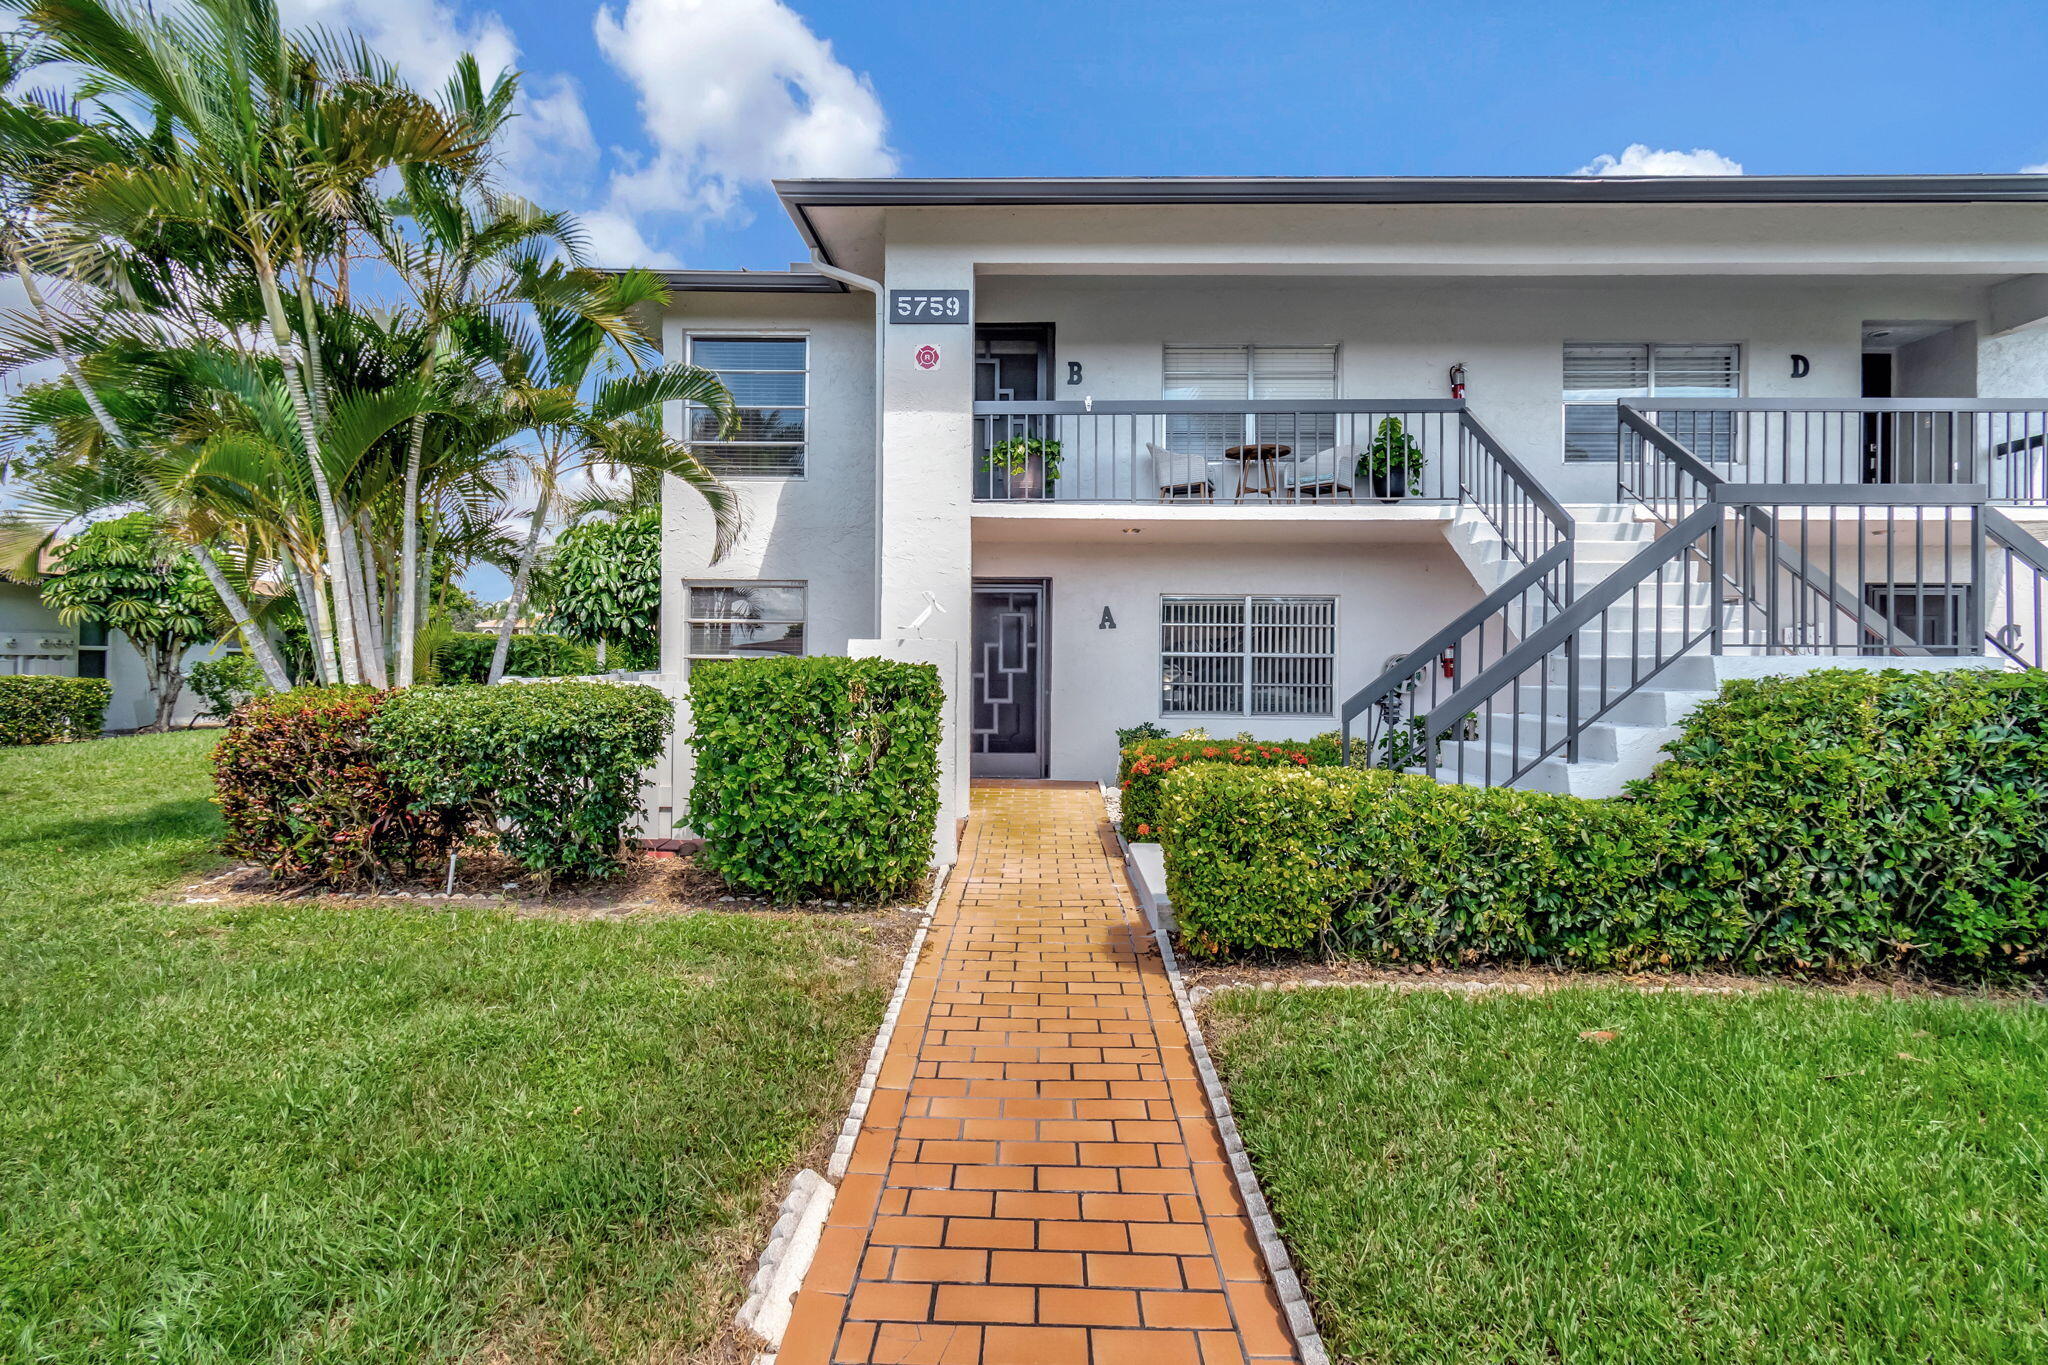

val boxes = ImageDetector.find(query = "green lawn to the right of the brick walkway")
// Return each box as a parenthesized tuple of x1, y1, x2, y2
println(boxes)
(1210, 988, 2048, 1361)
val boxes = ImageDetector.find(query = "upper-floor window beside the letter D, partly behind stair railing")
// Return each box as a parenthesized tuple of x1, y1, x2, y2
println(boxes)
(1565, 344, 1741, 460)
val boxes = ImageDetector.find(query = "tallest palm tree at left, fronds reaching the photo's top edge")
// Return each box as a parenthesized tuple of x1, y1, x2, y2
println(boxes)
(19, 0, 477, 681)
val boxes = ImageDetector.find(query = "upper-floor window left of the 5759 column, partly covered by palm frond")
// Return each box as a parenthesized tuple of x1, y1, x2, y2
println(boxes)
(684, 336, 811, 479)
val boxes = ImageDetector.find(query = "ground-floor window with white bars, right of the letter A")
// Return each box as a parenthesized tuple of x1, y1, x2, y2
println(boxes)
(1159, 598, 1337, 716)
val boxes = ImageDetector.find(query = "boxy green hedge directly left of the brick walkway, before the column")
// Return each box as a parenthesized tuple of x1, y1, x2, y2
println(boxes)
(690, 657, 944, 902)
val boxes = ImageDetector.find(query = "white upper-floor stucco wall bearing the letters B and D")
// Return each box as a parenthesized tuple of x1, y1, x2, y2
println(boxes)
(963, 274, 2015, 501)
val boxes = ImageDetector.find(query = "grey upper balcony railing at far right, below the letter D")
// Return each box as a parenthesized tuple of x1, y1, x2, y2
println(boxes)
(1622, 399, 2048, 508)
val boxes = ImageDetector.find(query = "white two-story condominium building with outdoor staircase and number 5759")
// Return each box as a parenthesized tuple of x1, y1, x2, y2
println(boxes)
(662, 176, 2048, 860)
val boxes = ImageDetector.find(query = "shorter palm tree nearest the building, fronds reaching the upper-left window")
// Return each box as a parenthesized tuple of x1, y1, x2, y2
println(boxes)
(489, 266, 739, 681)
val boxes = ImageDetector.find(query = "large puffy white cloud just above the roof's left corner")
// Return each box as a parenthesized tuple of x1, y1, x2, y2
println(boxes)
(596, 0, 897, 217)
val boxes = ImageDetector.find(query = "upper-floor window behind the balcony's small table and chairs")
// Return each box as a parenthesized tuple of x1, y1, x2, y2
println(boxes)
(1163, 346, 1337, 456)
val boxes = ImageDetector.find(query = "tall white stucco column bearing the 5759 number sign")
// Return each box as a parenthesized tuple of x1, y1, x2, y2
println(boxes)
(874, 250, 975, 862)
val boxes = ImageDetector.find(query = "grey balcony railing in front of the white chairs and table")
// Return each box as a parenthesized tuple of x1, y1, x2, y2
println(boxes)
(973, 399, 1483, 505)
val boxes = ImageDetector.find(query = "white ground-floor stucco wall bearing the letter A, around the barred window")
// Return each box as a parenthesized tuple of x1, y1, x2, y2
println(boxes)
(975, 526, 1481, 780)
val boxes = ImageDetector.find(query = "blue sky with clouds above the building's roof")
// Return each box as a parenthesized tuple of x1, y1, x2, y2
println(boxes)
(285, 0, 2048, 278)
